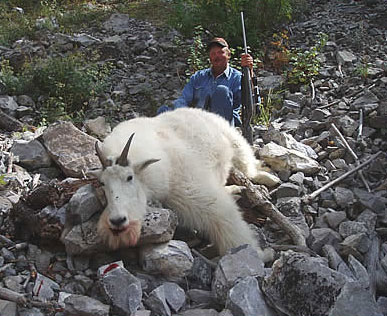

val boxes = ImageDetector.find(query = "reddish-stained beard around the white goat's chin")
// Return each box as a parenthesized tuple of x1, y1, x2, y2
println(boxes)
(97, 212, 141, 250)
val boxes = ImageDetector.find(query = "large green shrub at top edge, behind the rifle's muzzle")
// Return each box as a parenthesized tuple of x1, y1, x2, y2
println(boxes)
(171, 0, 306, 47)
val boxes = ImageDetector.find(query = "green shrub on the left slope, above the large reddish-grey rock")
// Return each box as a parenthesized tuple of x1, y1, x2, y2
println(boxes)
(0, 54, 112, 122)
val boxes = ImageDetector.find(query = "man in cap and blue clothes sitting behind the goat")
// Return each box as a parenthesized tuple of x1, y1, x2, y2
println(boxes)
(157, 37, 253, 126)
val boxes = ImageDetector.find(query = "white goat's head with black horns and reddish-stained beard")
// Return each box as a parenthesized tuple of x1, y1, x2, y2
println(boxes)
(95, 133, 158, 249)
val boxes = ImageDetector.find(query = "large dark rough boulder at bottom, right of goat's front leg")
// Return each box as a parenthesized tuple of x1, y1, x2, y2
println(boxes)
(262, 251, 347, 316)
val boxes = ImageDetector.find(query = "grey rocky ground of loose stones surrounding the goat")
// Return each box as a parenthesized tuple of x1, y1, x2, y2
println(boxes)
(0, 0, 387, 316)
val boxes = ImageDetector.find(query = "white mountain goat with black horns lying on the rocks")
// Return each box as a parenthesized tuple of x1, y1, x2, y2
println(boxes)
(96, 108, 273, 254)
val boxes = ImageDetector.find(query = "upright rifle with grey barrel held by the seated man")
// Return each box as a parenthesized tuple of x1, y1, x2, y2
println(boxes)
(241, 12, 255, 144)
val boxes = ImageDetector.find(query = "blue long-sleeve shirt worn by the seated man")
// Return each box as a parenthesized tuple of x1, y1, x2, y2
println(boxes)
(173, 66, 242, 122)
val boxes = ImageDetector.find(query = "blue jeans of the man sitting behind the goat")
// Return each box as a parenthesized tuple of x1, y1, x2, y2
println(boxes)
(157, 85, 241, 126)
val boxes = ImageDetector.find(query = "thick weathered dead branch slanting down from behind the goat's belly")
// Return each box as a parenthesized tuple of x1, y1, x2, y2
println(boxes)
(230, 168, 306, 247)
